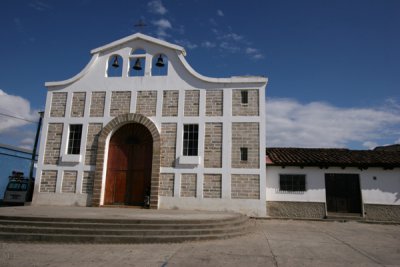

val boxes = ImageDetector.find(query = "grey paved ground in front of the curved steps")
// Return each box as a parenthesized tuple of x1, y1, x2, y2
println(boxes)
(0, 220, 400, 267)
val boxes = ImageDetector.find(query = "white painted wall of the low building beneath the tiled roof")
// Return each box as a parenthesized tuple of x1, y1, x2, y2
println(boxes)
(266, 166, 400, 205)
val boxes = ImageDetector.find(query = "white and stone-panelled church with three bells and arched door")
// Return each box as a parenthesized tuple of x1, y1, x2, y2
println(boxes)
(32, 33, 267, 217)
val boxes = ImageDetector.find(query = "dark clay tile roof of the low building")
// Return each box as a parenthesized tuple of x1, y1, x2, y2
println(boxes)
(266, 147, 400, 168)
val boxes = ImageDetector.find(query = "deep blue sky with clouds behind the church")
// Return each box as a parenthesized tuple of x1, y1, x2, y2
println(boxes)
(0, 0, 400, 149)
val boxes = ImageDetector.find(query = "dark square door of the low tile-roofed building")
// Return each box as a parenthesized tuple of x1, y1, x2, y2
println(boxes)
(325, 173, 361, 213)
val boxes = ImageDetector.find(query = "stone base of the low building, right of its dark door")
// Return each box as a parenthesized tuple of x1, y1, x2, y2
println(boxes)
(364, 204, 400, 222)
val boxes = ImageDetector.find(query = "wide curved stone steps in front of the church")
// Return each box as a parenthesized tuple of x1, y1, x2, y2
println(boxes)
(0, 214, 248, 243)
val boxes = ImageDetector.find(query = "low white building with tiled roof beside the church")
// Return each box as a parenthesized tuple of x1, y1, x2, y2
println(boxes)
(266, 149, 400, 221)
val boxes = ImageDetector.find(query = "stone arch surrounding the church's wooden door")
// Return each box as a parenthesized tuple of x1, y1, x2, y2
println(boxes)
(92, 113, 160, 209)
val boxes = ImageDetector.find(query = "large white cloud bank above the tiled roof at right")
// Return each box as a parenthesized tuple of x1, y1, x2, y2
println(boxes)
(266, 98, 400, 147)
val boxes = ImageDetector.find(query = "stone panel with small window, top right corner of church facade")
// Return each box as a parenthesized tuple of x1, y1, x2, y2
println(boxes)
(232, 90, 259, 116)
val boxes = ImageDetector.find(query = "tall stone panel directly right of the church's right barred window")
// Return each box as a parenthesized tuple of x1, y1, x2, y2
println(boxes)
(204, 122, 222, 168)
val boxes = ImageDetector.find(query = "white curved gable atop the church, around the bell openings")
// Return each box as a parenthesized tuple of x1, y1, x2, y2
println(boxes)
(45, 33, 267, 88)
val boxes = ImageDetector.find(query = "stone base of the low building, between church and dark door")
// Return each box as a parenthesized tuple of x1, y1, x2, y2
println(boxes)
(267, 201, 326, 219)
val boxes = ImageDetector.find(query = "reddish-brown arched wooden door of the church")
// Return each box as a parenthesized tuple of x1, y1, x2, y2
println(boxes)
(104, 123, 153, 206)
